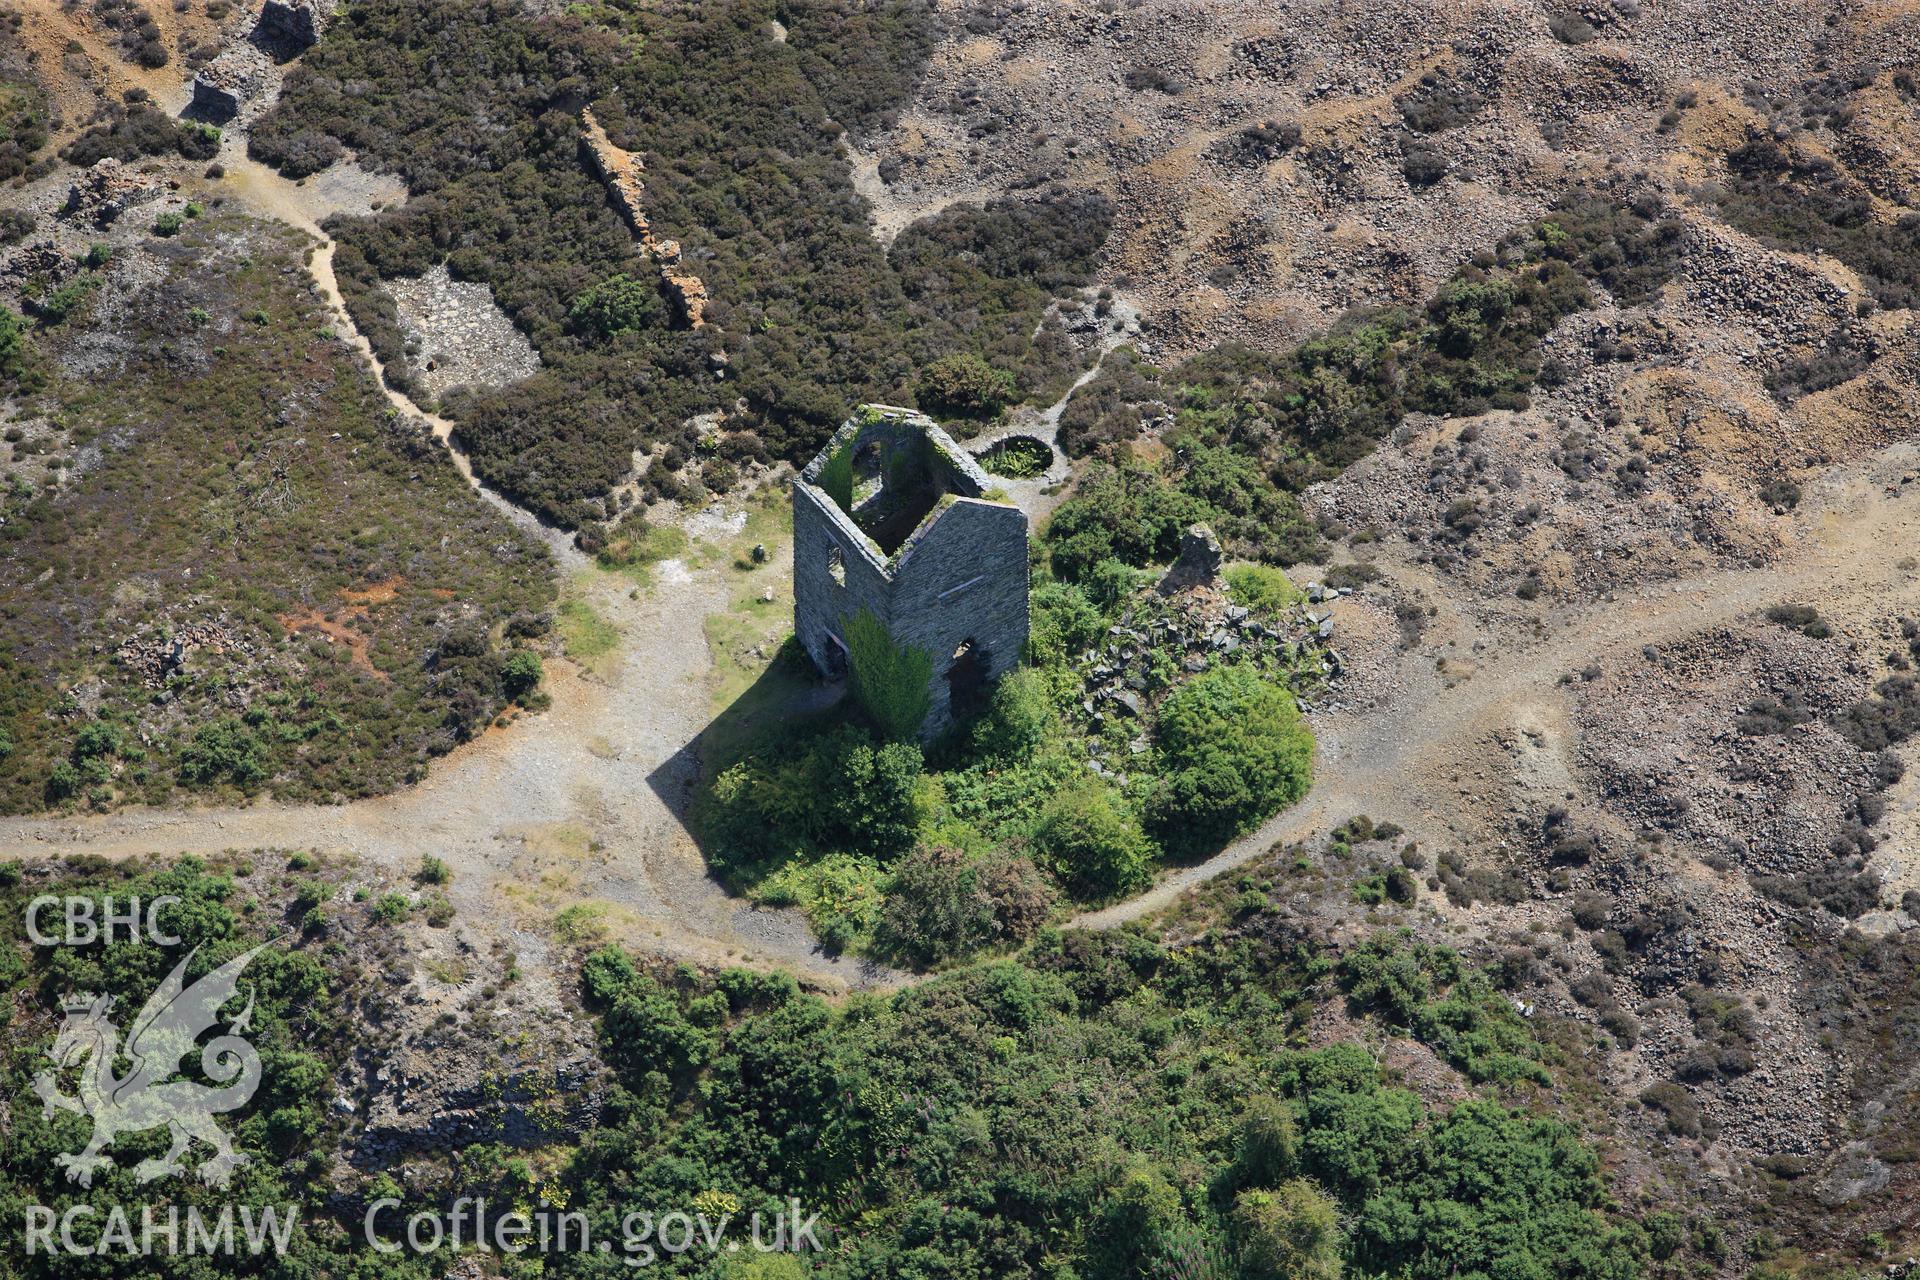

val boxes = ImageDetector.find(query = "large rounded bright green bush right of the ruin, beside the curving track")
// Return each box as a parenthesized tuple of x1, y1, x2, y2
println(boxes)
(1148, 666, 1313, 856)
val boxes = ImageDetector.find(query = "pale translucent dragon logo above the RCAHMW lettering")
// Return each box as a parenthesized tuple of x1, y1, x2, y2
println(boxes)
(33, 944, 265, 1188)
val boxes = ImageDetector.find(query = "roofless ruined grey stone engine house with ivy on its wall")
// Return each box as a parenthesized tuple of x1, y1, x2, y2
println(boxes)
(793, 405, 1027, 737)
